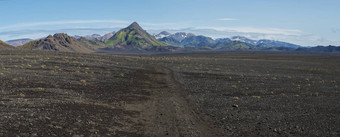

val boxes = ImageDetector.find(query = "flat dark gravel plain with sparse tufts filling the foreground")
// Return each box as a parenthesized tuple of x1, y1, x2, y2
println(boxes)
(0, 51, 340, 136)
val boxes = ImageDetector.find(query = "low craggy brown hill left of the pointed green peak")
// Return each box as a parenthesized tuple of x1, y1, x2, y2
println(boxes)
(19, 33, 104, 53)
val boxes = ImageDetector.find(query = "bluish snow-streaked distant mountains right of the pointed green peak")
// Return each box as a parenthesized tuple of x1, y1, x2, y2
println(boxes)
(155, 31, 301, 50)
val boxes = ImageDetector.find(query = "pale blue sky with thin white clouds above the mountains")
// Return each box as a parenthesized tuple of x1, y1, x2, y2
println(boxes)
(0, 0, 340, 46)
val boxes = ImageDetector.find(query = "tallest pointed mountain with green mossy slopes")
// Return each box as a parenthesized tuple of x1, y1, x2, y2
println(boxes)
(104, 22, 166, 49)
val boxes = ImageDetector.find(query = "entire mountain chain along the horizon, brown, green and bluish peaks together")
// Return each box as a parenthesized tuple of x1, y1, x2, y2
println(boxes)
(0, 22, 340, 53)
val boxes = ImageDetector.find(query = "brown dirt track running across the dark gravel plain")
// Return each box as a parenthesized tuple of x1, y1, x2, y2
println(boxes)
(126, 66, 221, 137)
